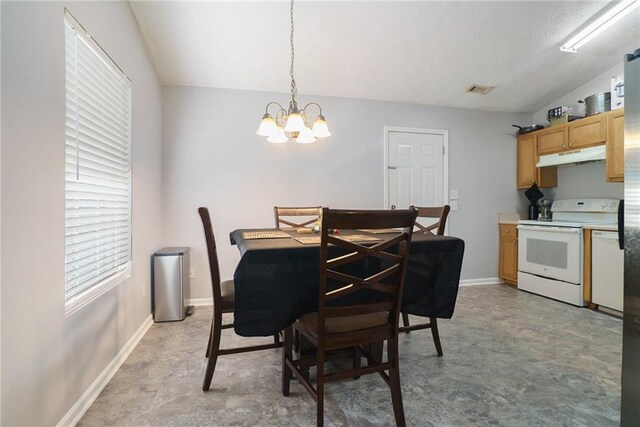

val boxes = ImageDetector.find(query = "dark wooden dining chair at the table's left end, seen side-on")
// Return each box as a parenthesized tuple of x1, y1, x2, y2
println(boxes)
(198, 207, 282, 391)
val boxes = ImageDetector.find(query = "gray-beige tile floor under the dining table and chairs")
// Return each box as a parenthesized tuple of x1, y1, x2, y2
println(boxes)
(79, 285, 622, 427)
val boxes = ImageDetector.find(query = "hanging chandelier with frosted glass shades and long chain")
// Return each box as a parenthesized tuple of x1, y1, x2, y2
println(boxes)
(258, 0, 331, 144)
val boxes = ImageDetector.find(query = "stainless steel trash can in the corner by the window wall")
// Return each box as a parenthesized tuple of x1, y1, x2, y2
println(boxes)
(152, 248, 192, 322)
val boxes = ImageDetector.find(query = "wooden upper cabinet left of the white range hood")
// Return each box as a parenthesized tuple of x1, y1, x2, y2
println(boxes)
(516, 132, 558, 188)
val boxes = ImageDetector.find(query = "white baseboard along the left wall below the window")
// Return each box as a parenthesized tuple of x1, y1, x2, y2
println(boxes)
(57, 315, 153, 427)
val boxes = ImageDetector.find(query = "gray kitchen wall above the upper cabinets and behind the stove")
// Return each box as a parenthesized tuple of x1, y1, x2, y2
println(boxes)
(533, 62, 624, 200)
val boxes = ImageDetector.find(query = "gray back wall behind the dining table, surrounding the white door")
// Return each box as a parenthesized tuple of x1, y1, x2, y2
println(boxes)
(162, 87, 530, 298)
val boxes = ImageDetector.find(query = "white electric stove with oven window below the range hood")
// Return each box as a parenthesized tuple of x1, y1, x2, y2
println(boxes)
(518, 199, 620, 307)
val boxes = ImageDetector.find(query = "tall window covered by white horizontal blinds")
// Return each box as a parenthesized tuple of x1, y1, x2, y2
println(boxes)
(65, 12, 131, 315)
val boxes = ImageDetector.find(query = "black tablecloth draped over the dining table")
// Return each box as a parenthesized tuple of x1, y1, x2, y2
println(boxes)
(230, 230, 464, 337)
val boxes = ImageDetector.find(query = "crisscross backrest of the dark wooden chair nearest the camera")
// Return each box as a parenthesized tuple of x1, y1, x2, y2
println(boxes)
(318, 208, 417, 336)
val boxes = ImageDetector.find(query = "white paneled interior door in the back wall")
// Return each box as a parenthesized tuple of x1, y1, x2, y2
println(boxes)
(385, 127, 449, 209)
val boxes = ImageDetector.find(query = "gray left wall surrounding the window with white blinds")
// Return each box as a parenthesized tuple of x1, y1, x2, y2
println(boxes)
(0, 1, 162, 425)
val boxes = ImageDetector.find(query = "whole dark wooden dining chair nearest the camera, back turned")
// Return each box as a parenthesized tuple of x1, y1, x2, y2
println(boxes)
(282, 208, 417, 426)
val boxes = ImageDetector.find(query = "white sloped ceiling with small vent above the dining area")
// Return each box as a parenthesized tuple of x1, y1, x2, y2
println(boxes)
(130, 1, 640, 112)
